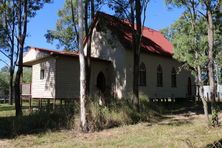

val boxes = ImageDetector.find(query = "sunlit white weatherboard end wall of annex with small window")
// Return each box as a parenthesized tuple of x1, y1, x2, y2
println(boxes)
(32, 58, 56, 98)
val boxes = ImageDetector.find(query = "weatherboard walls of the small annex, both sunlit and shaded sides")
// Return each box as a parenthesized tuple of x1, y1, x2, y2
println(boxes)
(32, 56, 112, 99)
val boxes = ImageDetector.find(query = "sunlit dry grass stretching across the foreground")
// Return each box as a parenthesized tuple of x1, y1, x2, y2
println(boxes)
(0, 102, 222, 148)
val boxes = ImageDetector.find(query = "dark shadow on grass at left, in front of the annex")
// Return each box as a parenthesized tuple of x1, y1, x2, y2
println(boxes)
(0, 104, 75, 139)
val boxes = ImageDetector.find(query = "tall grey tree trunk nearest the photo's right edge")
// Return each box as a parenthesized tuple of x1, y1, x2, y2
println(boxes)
(207, 9, 218, 126)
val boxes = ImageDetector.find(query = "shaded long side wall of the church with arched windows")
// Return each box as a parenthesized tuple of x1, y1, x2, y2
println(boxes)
(126, 50, 194, 98)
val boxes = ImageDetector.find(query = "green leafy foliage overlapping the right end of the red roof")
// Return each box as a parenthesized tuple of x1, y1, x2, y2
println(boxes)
(162, 14, 207, 71)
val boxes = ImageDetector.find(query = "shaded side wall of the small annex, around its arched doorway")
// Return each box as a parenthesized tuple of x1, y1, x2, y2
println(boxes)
(56, 57, 112, 98)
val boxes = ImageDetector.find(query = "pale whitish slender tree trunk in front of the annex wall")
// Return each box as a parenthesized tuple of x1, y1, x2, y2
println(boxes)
(78, 0, 88, 132)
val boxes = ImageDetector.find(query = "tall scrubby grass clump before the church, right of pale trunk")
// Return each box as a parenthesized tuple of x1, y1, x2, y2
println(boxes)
(87, 96, 159, 131)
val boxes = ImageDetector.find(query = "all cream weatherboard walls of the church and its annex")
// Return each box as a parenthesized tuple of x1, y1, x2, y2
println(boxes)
(30, 23, 194, 98)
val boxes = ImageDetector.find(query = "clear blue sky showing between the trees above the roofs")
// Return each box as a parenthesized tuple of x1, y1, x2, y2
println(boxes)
(0, 0, 183, 67)
